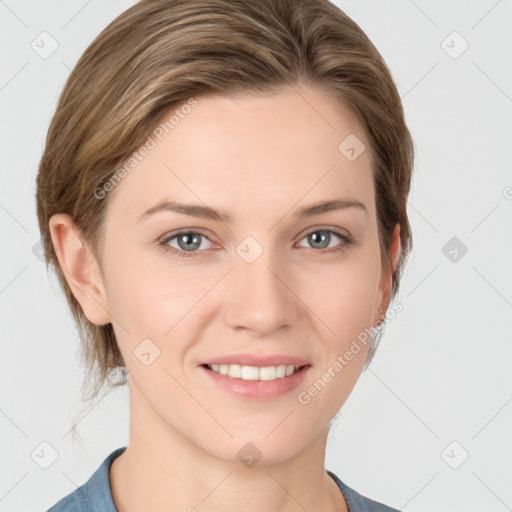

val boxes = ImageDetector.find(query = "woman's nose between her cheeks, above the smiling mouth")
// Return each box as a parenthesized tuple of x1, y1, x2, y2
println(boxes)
(223, 250, 307, 337)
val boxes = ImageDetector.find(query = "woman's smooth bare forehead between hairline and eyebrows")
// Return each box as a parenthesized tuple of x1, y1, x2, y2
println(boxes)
(111, 87, 373, 225)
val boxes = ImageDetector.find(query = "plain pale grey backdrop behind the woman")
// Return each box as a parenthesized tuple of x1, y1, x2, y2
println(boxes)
(0, 0, 512, 512)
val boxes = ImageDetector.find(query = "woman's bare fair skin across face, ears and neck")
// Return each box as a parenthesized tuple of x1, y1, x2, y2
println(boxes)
(50, 86, 400, 512)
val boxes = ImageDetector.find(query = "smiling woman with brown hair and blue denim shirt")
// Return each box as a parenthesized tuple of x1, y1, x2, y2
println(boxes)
(37, 0, 413, 512)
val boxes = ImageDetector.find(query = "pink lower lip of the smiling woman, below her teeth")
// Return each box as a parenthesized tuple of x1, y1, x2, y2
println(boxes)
(199, 365, 311, 400)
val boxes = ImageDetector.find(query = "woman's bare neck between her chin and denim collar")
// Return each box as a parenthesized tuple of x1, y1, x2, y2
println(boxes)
(110, 380, 348, 512)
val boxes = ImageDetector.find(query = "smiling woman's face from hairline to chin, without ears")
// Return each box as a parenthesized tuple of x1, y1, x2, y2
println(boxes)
(91, 87, 396, 464)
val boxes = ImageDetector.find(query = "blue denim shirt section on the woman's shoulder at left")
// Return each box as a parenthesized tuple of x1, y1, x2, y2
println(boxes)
(47, 446, 126, 512)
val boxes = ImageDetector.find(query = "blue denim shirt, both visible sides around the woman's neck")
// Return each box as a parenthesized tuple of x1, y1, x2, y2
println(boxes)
(47, 446, 400, 512)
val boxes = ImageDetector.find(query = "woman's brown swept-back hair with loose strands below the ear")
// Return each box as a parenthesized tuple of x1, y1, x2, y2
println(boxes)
(36, 0, 414, 410)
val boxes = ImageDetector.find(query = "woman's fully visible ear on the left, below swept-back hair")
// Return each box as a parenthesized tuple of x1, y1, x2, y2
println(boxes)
(49, 213, 111, 325)
